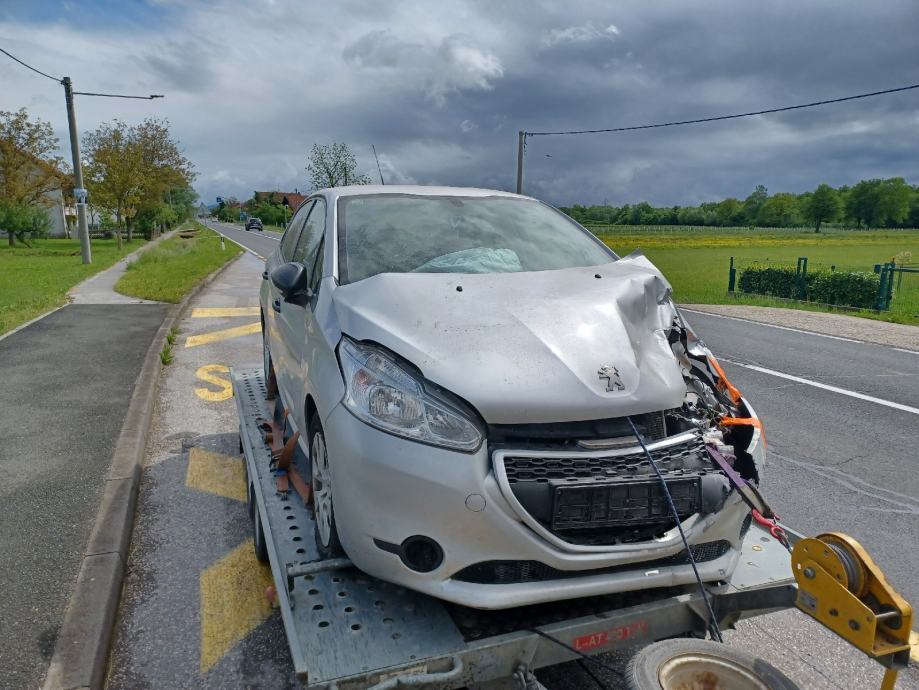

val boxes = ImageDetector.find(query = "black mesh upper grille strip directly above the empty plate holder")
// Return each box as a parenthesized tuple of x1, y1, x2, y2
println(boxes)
(504, 436, 705, 485)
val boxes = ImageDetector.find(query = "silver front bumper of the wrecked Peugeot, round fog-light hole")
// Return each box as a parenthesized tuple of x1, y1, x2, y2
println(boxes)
(324, 405, 762, 609)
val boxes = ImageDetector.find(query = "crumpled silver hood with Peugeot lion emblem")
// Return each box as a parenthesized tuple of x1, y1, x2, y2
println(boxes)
(332, 254, 686, 424)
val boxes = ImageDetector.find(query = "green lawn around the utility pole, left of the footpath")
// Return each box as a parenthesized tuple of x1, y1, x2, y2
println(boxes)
(0, 238, 144, 334)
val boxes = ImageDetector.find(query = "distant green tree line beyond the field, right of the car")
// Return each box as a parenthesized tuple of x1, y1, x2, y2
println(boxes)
(561, 177, 919, 232)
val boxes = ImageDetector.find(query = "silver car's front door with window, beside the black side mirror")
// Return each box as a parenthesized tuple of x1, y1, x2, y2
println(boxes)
(278, 197, 326, 430)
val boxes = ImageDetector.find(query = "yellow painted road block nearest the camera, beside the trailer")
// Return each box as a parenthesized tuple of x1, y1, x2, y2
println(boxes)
(200, 541, 273, 673)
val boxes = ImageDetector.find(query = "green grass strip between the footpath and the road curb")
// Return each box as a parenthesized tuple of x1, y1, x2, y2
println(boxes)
(115, 223, 242, 302)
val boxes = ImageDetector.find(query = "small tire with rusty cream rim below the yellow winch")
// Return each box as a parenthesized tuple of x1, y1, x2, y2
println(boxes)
(625, 639, 800, 690)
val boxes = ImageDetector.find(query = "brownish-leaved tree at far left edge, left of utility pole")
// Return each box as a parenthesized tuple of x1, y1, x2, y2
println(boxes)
(0, 108, 67, 246)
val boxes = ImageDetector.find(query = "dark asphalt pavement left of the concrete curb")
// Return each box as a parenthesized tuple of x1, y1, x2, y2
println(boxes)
(0, 304, 168, 688)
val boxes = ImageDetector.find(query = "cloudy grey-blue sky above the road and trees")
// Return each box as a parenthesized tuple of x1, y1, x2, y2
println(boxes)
(0, 0, 919, 205)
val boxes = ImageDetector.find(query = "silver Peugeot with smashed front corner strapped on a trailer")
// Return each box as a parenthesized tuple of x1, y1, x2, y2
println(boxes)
(260, 186, 765, 609)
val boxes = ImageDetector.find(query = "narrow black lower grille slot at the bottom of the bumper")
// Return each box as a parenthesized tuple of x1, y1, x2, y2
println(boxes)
(453, 539, 731, 585)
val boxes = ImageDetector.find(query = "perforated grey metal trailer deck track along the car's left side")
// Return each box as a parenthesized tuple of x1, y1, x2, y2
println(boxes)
(231, 369, 465, 686)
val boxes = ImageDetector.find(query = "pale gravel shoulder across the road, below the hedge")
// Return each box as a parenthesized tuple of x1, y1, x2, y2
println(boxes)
(680, 304, 919, 352)
